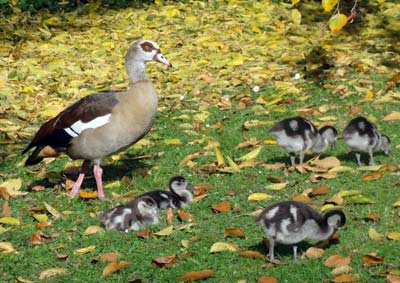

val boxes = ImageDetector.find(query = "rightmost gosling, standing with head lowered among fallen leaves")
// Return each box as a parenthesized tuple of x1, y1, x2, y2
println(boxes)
(343, 117, 390, 166)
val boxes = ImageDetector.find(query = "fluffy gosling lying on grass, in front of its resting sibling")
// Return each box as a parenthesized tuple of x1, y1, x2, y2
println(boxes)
(98, 196, 160, 232)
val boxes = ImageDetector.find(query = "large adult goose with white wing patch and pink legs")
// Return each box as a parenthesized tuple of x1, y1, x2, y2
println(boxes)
(23, 40, 172, 199)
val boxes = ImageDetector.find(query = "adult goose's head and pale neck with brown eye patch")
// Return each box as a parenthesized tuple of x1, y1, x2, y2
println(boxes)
(125, 40, 172, 83)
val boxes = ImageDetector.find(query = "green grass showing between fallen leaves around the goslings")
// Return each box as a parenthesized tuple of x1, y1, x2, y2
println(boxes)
(0, 78, 400, 282)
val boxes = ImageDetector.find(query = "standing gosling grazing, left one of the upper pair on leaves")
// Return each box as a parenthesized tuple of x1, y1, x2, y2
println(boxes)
(268, 117, 329, 165)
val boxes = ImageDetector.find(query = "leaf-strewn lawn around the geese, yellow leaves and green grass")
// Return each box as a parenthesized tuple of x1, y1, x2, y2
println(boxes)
(0, 1, 400, 283)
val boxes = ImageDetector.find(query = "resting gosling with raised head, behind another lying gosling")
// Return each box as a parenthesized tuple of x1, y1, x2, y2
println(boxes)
(136, 176, 193, 210)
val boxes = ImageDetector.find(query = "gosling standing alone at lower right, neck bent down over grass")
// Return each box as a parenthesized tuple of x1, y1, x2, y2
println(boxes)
(257, 201, 346, 262)
